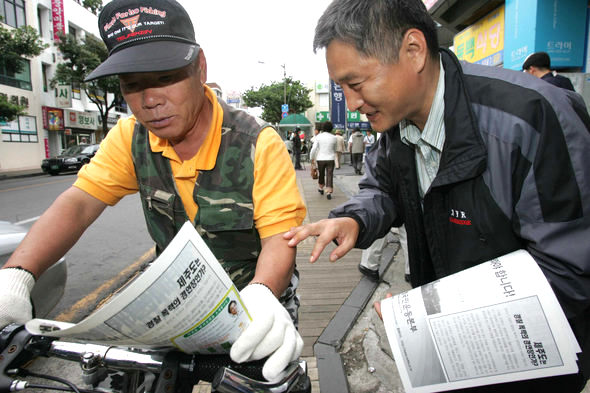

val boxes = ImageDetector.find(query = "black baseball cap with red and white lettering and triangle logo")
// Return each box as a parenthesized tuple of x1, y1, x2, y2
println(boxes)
(84, 0, 199, 82)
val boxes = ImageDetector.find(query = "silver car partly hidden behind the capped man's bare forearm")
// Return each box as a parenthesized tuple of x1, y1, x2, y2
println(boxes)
(0, 221, 68, 317)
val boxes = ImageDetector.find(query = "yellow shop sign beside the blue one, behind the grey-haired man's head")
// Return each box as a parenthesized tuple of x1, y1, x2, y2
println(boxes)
(453, 6, 504, 65)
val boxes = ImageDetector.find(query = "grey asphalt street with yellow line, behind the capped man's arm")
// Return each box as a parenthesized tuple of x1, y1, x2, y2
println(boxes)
(0, 174, 153, 322)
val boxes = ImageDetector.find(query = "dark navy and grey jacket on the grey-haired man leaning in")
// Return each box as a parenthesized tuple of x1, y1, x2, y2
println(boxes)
(330, 50, 590, 386)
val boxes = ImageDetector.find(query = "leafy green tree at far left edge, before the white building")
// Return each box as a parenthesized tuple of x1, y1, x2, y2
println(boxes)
(0, 25, 47, 121)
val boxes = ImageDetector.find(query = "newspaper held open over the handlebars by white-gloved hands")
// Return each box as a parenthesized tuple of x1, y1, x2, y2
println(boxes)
(25, 222, 251, 354)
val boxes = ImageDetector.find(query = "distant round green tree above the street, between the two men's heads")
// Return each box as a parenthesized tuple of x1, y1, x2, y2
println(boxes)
(242, 78, 313, 123)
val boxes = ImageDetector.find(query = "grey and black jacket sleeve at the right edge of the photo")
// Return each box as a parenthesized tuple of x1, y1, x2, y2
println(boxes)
(513, 84, 590, 318)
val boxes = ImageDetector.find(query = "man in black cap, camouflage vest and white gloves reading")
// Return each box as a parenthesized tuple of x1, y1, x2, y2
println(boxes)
(0, 0, 305, 380)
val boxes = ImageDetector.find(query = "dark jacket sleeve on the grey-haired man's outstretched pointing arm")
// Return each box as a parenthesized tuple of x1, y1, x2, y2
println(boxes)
(329, 135, 402, 248)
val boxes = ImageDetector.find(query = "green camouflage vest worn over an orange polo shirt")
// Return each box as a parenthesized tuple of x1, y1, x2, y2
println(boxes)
(131, 102, 267, 289)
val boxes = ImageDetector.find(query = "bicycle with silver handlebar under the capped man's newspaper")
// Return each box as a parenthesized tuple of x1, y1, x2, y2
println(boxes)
(0, 324, 311, 393)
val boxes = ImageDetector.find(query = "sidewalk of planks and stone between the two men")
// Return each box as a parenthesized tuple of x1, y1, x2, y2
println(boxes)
(297, 163, 409, 393)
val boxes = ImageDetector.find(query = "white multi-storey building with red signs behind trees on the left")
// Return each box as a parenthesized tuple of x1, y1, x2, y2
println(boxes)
(0, 0, 128, 174)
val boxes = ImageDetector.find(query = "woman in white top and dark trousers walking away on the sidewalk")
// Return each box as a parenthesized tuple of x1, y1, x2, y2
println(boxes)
(310, 121, 336, 199)
